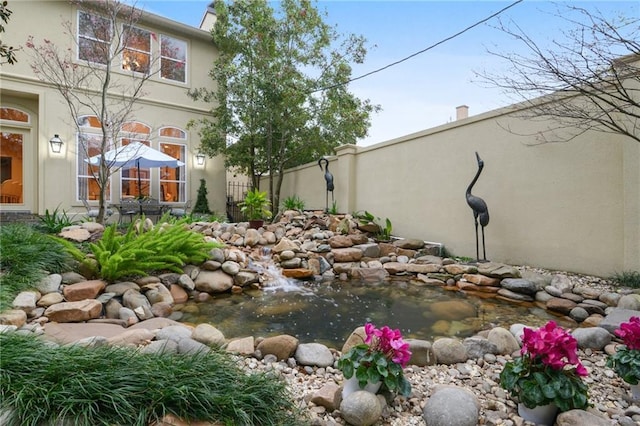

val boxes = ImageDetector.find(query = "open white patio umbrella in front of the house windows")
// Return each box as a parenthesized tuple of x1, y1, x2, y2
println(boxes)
(85, 142, 184, 195)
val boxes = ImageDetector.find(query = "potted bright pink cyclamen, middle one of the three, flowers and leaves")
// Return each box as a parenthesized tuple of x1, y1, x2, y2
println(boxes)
(500, 321, 589, 417)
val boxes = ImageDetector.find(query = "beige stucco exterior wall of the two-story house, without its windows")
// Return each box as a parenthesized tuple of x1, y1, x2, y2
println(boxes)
(0, 1, 226, 214)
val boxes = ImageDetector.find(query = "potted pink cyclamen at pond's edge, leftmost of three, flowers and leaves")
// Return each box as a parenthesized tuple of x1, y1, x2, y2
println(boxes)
(338, 323, 411, 396)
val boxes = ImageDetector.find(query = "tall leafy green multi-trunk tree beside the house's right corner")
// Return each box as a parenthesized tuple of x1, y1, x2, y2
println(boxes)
(190, 0, 378, 213)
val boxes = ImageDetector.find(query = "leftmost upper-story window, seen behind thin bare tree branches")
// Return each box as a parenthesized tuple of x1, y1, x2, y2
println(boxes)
(78, 11, 113, 65)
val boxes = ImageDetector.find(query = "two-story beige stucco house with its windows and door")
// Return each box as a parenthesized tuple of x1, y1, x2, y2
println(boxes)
(0, 1, 226, 221)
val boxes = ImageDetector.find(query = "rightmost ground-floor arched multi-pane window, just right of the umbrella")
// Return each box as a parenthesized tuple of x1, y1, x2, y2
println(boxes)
(160, 127, 187, 203)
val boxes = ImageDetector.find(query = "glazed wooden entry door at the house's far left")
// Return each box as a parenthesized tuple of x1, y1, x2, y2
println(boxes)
(0, 127, 33, 211)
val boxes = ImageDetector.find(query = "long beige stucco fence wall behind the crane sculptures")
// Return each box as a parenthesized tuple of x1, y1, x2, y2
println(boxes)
(272, 109, 640, 277)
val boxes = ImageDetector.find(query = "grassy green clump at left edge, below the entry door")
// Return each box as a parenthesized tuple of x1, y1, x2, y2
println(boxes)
(0, 223, 71, 311)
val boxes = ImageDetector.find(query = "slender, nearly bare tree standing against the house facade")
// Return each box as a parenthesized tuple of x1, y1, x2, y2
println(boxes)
(27, 0, 153, 223)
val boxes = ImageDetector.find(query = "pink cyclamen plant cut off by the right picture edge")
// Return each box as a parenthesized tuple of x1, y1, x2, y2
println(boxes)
(607, 317, 640, 398)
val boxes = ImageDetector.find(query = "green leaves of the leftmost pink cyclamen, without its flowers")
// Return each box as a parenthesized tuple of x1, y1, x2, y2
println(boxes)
(338, 343, 411, 396)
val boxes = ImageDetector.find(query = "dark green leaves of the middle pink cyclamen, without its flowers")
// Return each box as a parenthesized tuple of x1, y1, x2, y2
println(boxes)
(500, 356, 589, 412)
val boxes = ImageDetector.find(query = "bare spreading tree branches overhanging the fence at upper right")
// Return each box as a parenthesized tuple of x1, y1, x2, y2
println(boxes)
(478, 6, 640, 143)
